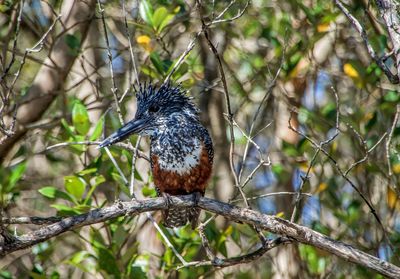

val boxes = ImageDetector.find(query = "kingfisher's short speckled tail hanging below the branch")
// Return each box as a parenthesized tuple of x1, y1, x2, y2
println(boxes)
(162, 207, 201, 229)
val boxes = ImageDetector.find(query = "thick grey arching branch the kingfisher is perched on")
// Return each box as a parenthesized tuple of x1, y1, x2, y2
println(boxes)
(0, 195, 400, 278)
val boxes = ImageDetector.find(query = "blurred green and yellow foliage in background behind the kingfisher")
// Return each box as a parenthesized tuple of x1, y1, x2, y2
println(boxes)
(0, 0, 400, 278)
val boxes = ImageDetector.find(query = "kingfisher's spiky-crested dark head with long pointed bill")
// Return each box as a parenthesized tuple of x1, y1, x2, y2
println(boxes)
(99, 84, 198, 148)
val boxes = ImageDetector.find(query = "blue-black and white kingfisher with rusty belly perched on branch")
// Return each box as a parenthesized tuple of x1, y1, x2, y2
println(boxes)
(99, 83, 214, 229)
